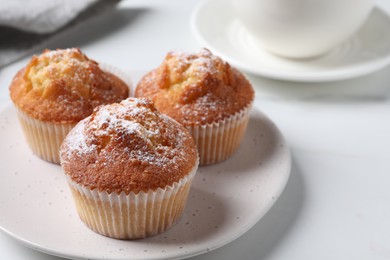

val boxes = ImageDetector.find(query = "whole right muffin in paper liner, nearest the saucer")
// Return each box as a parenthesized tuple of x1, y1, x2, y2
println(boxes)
(135, 49, 254, 165)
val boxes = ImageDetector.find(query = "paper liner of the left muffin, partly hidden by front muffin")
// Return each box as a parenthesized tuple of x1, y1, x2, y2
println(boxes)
(17, 108, 76, 164)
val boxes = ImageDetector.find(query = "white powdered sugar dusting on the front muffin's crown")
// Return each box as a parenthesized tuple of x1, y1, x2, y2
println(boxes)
(62, 99, 195, 170)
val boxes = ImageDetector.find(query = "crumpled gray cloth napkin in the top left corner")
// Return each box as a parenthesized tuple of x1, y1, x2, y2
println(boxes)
(0, 0, 119, 68)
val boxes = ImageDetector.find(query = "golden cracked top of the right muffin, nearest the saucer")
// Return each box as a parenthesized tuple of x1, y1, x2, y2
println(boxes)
(135, 49, 254, 126)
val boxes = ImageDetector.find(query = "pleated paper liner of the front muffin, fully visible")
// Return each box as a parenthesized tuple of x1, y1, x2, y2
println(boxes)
(66, 161, 198, 239)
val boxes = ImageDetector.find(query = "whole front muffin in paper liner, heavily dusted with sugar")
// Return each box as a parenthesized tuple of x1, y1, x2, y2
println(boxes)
(60, 98, 199, 239)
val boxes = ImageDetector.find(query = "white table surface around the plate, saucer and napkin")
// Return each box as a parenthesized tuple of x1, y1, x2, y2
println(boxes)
(0, 0, 390, 260)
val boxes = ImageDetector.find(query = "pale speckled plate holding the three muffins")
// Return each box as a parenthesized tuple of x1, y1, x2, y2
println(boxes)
(0, 97, 291, 259)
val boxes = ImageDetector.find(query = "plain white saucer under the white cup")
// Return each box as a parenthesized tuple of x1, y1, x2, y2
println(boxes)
(191, 0, 390, 82)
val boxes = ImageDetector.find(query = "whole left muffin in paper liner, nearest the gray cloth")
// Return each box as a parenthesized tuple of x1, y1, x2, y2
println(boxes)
(10, 48, 129, 164)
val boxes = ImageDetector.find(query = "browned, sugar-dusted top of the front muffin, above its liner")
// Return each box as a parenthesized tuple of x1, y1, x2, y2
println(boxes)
(60, 98, 198, 194)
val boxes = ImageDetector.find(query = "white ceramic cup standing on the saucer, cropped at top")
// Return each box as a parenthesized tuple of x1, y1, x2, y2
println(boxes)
(231, 0, 374, 58)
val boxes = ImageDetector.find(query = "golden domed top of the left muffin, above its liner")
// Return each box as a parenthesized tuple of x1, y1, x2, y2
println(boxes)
(10, 48, 129, 123)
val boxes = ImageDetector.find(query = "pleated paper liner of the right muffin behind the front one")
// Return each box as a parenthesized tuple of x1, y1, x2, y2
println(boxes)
(186, 102, 252, 166)
